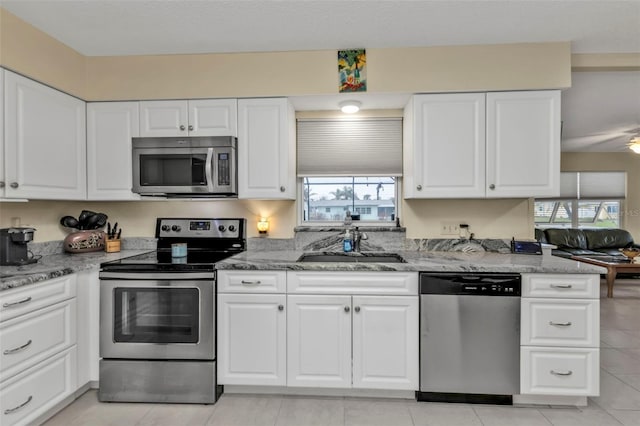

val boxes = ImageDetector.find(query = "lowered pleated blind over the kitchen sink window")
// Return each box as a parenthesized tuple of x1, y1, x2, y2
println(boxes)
(297, 118, 402, 176)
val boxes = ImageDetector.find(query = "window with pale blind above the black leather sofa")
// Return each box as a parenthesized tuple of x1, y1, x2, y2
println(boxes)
(534, 172, 626, 228)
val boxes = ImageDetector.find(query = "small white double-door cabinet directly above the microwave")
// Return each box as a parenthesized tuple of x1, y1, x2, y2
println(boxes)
(140, 99, 238, 137)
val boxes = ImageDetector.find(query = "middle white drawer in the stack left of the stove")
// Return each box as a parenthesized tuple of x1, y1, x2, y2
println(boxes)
(0, 299, 76, 380)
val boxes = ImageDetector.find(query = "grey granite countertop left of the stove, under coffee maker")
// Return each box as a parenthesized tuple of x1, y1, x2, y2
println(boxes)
(0, 249, 150, 291)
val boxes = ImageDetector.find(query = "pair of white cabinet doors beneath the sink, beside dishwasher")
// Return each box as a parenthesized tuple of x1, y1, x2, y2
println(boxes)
(287, 295, 419, 390)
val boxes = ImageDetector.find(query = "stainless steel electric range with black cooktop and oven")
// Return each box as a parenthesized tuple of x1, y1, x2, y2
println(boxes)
(98, 218, 246, 404)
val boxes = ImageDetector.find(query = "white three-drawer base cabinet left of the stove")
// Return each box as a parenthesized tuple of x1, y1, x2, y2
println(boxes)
(0, 274, 77, 426)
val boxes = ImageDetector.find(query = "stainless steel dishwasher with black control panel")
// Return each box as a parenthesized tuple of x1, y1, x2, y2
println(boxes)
(417, 273, 521, 404)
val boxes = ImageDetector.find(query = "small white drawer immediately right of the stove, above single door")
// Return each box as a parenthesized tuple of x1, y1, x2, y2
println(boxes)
(218, 271, 287, 293)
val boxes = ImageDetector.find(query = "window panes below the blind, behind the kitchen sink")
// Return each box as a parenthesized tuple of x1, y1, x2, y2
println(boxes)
(302, 176, 397, 223)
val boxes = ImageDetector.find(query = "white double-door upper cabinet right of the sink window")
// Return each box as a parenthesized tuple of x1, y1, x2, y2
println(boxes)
(404, 90, 560, 198)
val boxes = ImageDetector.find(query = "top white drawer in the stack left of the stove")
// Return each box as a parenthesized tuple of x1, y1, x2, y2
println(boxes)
(0, 274, 76, 322)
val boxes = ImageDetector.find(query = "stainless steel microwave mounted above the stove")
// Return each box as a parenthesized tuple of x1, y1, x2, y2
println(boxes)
(132, 136, 238, 197)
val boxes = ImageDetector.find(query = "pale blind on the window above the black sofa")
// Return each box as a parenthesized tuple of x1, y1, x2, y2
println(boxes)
(553, 172, 627, 200)
